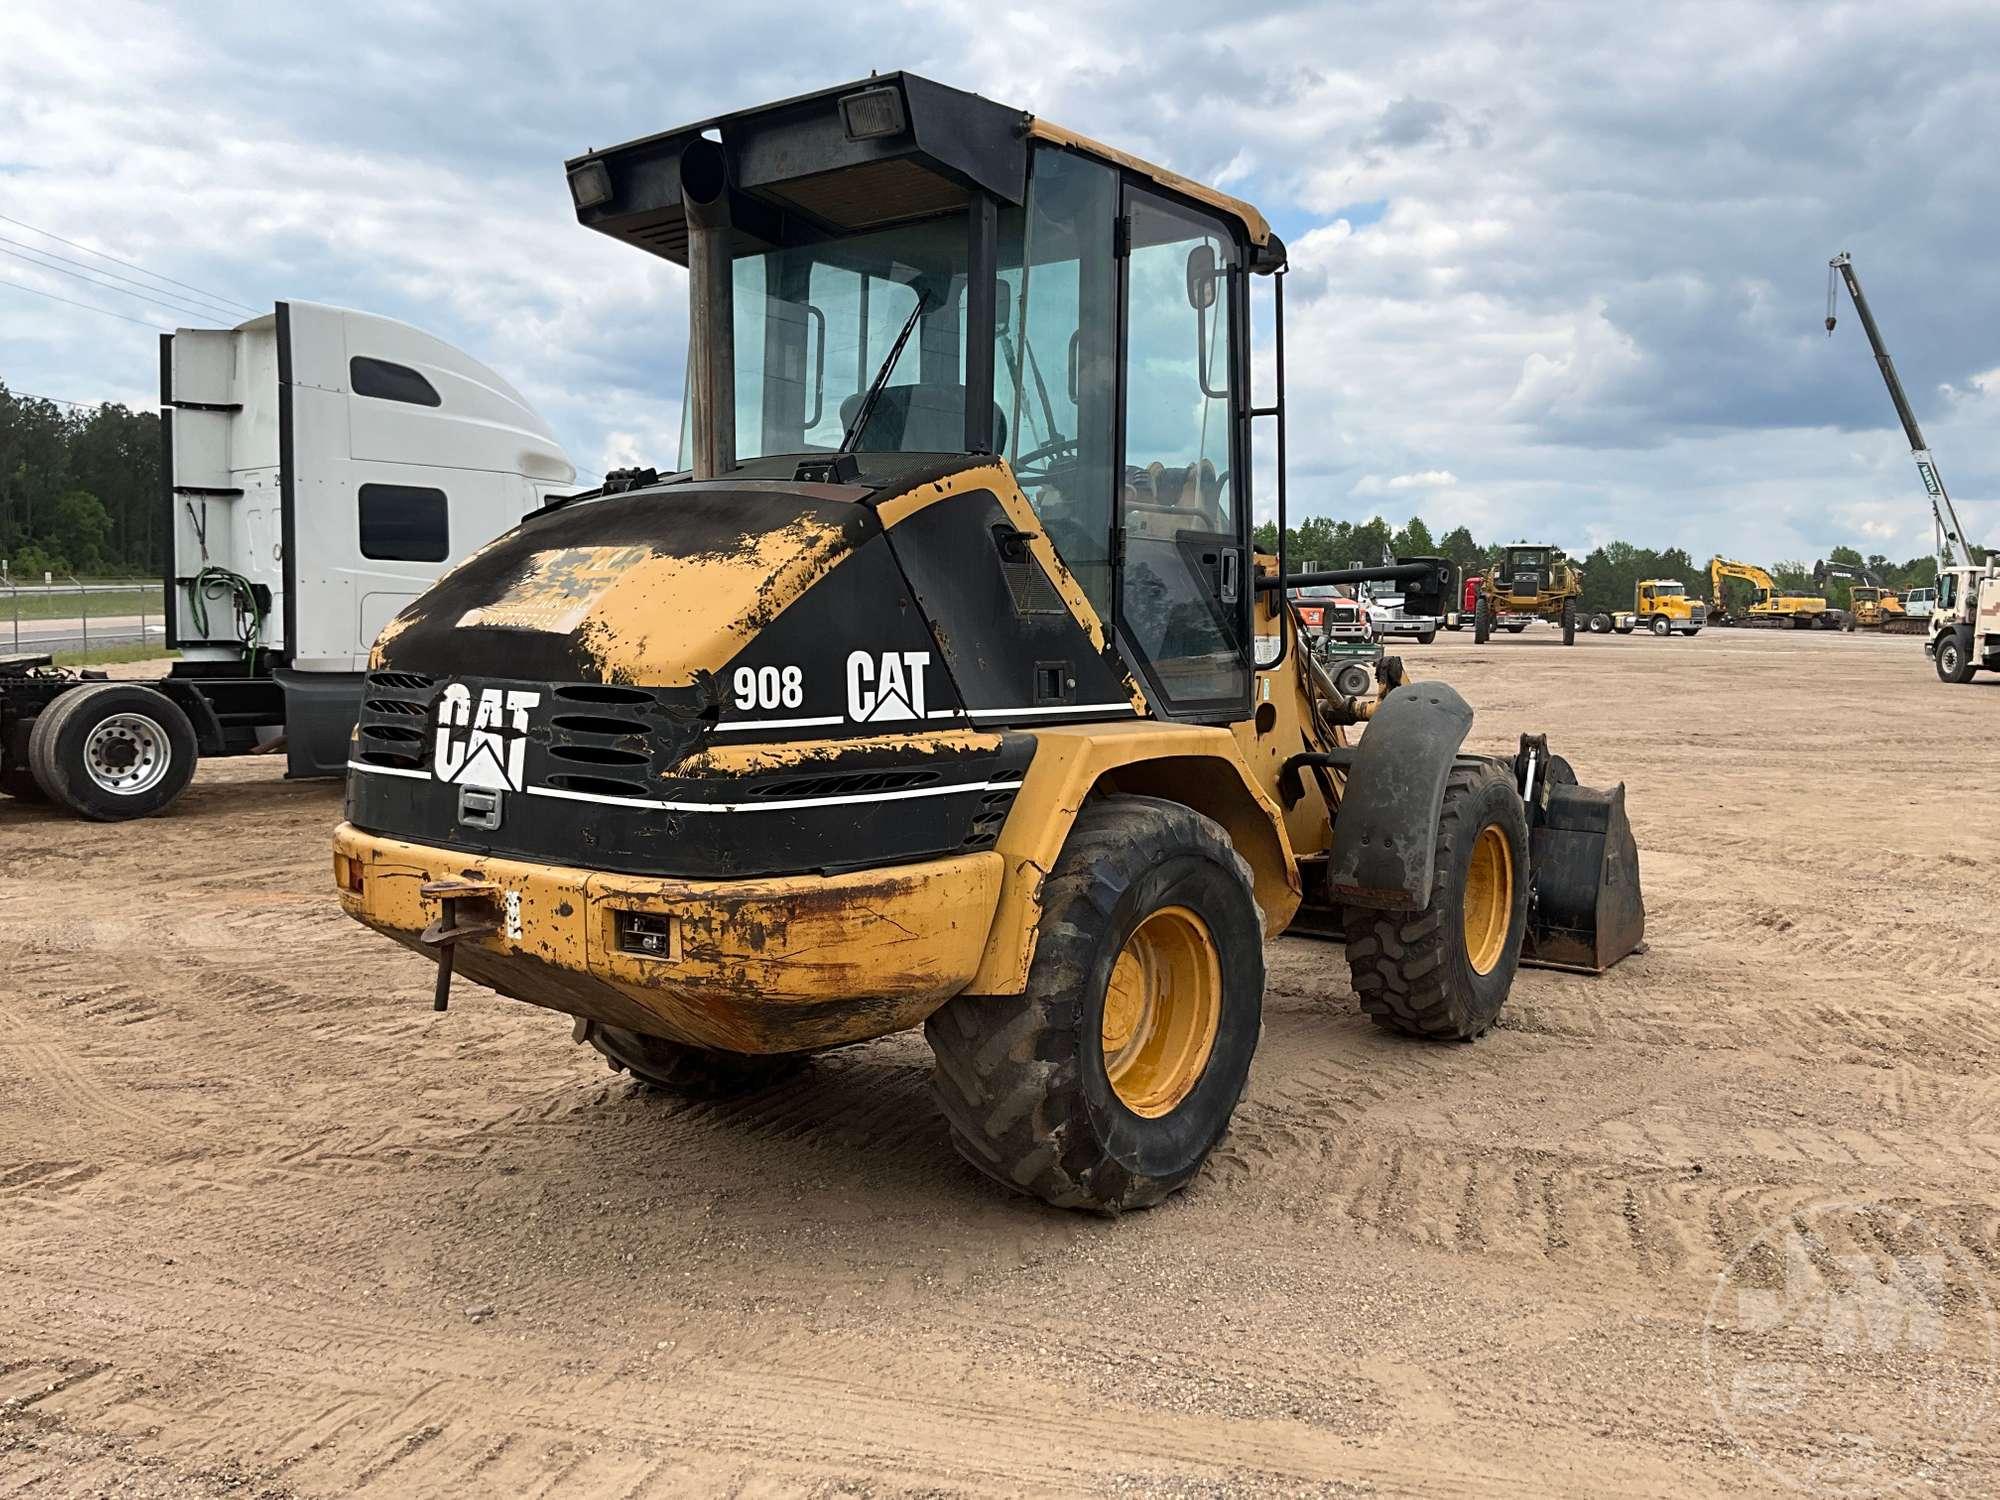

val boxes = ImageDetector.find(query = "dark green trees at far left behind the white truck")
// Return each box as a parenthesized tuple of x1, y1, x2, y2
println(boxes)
(0, 382, 166, 582)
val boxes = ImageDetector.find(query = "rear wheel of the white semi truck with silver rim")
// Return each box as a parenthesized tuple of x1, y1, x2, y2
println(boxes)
(28, 682, 198, 822)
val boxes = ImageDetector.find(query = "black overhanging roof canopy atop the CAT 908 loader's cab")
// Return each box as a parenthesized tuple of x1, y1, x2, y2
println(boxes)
(568, 72, 1284, 270)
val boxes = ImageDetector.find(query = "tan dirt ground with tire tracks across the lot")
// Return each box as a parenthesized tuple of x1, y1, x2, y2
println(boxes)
(0, 626, 2000, 1498)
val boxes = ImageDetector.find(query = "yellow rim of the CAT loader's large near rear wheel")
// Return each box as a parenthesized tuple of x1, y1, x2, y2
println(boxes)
(1102, 906, 1222, 1118)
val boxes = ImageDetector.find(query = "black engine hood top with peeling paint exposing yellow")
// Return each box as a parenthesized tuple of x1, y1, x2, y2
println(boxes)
(374, 480, 882, 686)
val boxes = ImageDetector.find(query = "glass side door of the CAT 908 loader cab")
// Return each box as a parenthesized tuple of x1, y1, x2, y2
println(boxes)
(1116, 184, 1254, 722)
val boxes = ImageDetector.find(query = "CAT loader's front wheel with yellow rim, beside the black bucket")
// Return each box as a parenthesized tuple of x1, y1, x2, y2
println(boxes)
(1346, 760, 1528, 1042)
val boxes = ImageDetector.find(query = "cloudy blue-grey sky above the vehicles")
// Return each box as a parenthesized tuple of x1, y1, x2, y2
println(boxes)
(0, 0, 2000, 560)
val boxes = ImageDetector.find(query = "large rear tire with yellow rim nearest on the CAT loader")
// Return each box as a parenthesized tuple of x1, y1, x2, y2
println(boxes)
(924, 796, 1264, 1214)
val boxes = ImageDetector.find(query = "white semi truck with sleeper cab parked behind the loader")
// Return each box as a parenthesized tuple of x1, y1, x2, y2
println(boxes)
(0, 302, 576, 820)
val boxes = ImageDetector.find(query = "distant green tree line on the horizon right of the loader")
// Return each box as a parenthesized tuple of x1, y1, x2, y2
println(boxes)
(1256, 516, 1938, 610)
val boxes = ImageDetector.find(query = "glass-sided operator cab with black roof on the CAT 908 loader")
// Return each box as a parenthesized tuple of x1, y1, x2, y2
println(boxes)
(592, 74, 1284, 722)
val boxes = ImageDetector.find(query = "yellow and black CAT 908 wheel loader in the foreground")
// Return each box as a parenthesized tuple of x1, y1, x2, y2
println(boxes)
(334, 74, 1644, 1212)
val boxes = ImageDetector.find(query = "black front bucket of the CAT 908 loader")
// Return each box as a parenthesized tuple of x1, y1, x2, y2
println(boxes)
(1520, 782, 1646, 974)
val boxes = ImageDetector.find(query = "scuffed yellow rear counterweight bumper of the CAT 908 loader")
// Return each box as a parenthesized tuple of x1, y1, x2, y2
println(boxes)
(334, 824, 1004, 1052)
